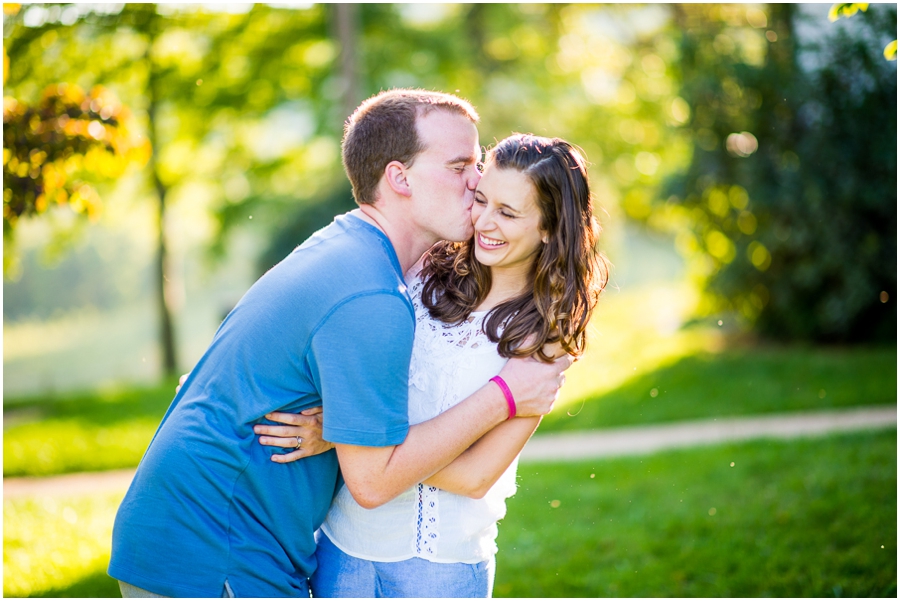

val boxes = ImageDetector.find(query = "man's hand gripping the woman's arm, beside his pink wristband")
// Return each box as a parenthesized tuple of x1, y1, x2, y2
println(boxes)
(500, 354, 575, 417)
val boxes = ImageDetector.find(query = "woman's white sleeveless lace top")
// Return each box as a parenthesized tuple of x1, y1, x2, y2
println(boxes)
(322, 277, 518, 563)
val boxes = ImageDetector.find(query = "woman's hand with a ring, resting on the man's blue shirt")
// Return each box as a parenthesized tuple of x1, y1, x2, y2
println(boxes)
(253, 407, 334, 463)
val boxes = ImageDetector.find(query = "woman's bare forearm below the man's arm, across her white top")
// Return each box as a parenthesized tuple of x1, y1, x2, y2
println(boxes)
(425, 417, 541, 499)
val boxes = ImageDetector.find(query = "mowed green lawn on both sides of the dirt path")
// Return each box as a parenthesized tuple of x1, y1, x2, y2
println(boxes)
(3, 331, 897, 597)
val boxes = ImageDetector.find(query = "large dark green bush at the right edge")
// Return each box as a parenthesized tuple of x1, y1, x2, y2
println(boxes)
(649, 4, 897, 341)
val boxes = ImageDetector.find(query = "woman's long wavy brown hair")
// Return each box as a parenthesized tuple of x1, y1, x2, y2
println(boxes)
(422, 134, 609, 361)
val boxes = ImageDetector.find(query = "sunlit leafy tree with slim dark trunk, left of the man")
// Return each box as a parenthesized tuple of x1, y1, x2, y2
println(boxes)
(4, 4, 339, 372)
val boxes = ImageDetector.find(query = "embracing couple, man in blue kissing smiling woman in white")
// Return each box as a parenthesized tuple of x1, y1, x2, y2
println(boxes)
(109, 90, 607, 597)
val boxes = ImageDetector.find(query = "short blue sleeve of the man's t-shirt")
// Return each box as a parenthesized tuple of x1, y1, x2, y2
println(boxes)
(307, 292, 415, 447)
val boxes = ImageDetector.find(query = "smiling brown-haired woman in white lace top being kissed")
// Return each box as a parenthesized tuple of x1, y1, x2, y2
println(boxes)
(261, 134, 607, 597)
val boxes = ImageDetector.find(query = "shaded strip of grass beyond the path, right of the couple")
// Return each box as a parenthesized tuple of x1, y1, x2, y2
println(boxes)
(541, 346, 897, 432)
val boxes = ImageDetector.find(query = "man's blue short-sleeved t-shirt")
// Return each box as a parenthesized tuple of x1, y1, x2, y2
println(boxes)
(109, 215, 415, 597)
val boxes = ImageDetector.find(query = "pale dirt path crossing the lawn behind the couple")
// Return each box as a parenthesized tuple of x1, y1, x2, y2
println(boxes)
(3, 406, 897, 499)
